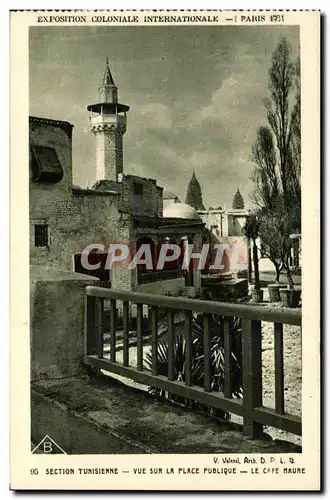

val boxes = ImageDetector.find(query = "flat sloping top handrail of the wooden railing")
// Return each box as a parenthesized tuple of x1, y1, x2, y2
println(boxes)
(86, 286, 301, 326)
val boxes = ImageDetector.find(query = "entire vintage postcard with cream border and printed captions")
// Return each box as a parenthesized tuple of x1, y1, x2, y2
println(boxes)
(10, 10, 321, 491)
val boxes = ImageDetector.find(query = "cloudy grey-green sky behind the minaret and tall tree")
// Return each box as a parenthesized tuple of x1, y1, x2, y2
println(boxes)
(30, 26, 299, 207)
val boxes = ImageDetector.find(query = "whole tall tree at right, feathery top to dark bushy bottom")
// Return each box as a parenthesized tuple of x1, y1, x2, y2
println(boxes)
(252, 38, 301, 285)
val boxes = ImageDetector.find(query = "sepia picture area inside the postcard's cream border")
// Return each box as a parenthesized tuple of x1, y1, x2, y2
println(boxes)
(29, 21, 302, 453)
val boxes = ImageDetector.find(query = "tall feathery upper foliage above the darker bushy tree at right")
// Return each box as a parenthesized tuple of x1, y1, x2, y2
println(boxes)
(252, 39, 301, 230)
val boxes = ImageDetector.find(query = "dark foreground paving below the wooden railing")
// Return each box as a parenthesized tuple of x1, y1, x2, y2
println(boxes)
(32, 377, 301, 453)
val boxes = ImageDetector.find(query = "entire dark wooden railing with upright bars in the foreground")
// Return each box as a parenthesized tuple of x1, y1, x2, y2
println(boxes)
(85, 286, 301, 438)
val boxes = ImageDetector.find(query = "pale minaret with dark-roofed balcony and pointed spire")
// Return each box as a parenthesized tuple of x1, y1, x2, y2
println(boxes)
(87, 58, 129, 182)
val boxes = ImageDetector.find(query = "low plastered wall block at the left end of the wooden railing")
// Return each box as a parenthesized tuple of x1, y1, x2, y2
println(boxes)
(30, 266, 99, 380)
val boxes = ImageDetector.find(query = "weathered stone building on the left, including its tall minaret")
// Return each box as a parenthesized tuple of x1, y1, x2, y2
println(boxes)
(29, 61, 204, 295)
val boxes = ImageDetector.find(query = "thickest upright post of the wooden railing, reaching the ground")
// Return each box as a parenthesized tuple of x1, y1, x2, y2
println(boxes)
(242, 320, 263, 438)
